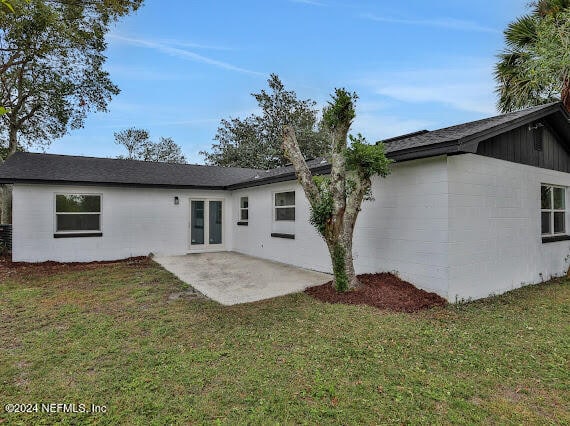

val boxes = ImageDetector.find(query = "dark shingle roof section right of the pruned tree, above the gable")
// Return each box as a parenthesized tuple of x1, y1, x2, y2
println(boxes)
(381, 102, 568, 159)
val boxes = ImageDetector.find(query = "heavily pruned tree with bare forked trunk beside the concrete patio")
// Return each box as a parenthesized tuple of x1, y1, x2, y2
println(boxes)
(283, 89, 391, 291)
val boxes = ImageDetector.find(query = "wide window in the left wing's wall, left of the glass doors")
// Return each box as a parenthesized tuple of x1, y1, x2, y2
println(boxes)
(55, 194, 101, 233)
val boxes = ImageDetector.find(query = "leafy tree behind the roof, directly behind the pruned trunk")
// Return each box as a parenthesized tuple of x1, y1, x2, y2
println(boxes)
(200, 74, 329, 169)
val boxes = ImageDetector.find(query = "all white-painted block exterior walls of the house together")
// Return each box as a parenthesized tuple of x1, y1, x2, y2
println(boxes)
(13, 154, 570, 301)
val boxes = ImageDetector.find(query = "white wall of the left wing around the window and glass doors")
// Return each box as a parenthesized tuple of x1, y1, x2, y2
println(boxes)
(13, 184, 233, 262)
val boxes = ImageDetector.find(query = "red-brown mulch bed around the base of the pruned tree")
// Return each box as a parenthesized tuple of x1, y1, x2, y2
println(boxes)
(305, 272, 447, 312)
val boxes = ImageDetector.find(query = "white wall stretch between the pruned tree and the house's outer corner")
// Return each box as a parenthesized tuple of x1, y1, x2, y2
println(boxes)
(353, 156, 449, 297)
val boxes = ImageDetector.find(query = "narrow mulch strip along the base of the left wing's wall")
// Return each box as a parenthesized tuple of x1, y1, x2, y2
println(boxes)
(0, 255, 150, 276)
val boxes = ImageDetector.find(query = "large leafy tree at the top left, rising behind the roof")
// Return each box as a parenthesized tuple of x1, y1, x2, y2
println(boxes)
(0, 0, 143, 223)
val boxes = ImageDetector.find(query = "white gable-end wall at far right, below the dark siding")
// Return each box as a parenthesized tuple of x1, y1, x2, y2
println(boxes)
(448, 154, 570, 301)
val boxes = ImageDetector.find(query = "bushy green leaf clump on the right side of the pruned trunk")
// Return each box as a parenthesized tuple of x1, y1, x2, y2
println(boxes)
(346, 133, 393, 179)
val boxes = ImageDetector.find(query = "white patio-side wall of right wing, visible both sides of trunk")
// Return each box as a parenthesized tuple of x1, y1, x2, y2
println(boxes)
(233, 157, 448, 296)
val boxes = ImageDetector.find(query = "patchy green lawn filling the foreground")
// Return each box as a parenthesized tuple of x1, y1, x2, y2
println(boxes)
(0, 262, 570, 424)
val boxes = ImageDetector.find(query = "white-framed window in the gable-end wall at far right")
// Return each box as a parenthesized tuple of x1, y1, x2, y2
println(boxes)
(540, 185, 566, 236)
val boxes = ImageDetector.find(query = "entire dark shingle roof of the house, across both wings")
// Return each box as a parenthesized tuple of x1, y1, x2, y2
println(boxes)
(0, 102, 570, 189)
